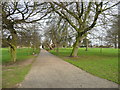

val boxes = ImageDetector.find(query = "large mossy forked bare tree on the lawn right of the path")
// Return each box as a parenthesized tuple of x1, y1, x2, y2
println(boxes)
(50, 1, 120, 57)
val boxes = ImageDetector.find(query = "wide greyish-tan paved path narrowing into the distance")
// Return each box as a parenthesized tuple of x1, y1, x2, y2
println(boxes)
(19, 50, 118, 88)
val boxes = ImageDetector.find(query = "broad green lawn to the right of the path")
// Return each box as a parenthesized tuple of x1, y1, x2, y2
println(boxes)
(50, 48, 120, 84)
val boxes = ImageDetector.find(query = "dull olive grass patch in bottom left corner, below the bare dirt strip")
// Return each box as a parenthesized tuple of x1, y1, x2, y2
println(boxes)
(2, 65, 31, 88)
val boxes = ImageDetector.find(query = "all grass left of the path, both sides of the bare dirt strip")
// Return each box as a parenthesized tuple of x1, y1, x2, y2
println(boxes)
(0, 48, 39, 88)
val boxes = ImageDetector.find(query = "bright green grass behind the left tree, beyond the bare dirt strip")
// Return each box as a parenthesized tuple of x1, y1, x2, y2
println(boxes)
(0, 48, 39, 64)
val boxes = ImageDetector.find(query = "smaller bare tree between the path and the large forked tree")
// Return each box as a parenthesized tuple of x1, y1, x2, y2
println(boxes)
(45, 17, 70, 52)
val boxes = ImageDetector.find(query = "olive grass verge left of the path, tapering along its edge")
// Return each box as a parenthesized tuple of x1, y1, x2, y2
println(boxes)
(2, 56, 37, 88)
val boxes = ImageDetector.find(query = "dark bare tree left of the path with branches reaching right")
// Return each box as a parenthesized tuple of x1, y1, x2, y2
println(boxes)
(2, 1, 49, 62)
